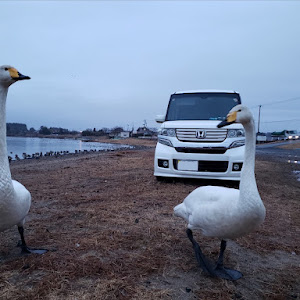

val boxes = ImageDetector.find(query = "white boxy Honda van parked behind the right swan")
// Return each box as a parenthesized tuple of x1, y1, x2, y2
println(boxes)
(154, 90, 245, 181)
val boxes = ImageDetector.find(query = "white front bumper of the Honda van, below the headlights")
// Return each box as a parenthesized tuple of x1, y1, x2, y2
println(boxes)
(154, 143, 245, 181)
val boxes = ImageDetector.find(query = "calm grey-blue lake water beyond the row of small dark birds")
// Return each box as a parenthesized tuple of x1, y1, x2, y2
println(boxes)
(7, 136, 132, 159)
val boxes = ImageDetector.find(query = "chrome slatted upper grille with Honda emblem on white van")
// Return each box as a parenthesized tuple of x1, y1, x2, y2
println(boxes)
(176, 128, 227, 143)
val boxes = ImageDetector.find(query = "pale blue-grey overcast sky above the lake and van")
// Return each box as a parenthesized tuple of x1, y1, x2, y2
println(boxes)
(0, 1, 300, 131)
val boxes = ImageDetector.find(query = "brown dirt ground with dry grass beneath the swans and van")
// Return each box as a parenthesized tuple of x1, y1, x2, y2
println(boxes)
(0, 141, 300, 300)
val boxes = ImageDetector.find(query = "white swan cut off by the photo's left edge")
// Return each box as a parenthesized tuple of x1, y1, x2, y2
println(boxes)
(0, 65, 47, 253)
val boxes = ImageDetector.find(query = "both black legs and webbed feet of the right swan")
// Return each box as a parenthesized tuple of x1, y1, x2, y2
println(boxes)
(186, 229, 243, 280)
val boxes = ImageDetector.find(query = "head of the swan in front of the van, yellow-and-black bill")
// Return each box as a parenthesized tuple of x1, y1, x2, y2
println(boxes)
(217, 104, 253, 128)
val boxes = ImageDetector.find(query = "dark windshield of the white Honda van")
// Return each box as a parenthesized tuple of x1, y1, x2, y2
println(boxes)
(166, 93, 241, 121)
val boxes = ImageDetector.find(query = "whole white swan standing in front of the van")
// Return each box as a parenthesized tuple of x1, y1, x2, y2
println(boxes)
(174, 105, 266, 280)
